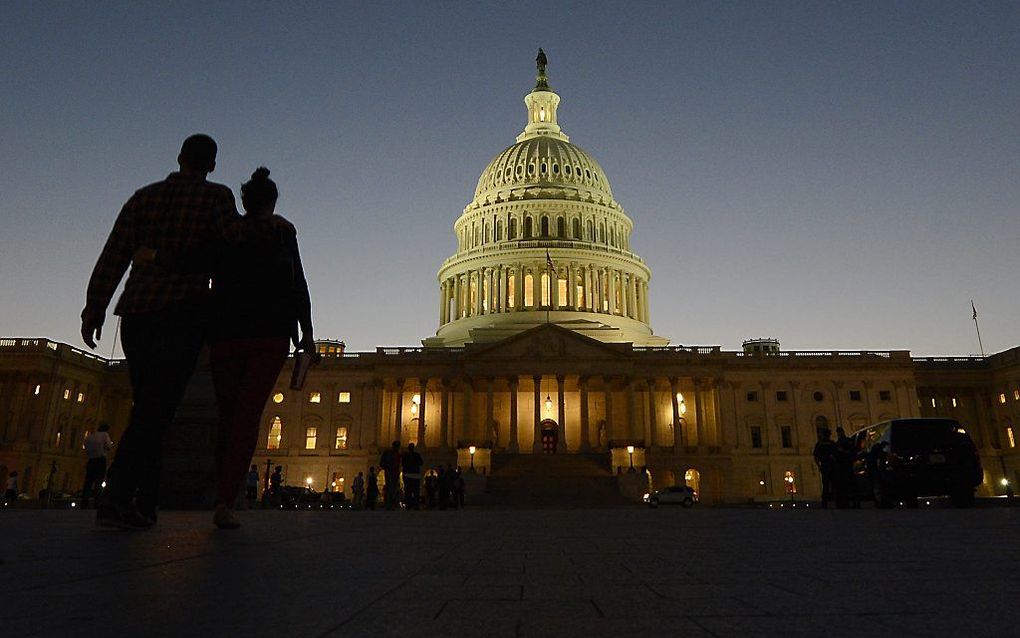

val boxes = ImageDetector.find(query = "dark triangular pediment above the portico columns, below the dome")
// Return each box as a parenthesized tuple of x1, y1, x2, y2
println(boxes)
(465, 324, 631, 360)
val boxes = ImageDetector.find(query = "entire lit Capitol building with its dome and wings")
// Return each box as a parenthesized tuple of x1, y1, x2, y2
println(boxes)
(0, 51, 1020, 504)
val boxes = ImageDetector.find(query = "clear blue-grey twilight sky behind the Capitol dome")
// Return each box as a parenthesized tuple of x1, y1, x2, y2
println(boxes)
(0, 1, 1020, 355)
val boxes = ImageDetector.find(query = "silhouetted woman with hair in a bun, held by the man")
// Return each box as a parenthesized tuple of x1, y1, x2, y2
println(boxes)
(210, 167, 315, 529)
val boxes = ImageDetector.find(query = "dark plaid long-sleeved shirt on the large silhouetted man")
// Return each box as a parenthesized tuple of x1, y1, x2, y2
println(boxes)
(83, 173, 241, 315)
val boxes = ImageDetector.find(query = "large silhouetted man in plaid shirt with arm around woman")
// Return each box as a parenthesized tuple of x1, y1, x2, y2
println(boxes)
(82, 135, 240, 528)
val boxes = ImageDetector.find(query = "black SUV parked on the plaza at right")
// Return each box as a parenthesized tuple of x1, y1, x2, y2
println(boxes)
(851, 419, 982, 507)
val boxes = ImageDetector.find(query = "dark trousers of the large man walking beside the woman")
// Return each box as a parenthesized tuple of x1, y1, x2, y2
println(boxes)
(107, 305, 208, 520)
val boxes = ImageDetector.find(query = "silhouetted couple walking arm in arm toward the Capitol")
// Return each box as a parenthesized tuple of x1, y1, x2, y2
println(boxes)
(82, 135, 314, 529)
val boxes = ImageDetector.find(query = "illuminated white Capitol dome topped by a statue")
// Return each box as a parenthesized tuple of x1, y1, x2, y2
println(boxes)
(423, 49, 669, 347)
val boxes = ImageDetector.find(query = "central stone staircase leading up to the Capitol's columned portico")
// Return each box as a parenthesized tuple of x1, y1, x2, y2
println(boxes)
(475, 454, 640, 509)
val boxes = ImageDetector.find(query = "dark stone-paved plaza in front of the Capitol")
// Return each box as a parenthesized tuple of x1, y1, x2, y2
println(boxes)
(0, 507, 1020, 638)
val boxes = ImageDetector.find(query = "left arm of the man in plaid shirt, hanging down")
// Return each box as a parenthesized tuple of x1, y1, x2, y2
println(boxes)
(82, 196, 135, 348)
